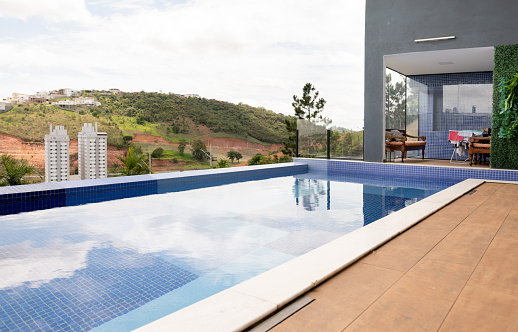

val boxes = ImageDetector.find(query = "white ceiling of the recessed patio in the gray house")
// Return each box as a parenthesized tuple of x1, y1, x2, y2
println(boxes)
(385, 47, 495, 76)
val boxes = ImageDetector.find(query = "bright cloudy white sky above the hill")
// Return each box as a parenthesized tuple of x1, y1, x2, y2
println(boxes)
(0, 0, 365, 129)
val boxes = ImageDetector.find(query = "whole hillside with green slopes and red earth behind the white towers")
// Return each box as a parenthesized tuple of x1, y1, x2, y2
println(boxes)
(0, 93, 285, 172)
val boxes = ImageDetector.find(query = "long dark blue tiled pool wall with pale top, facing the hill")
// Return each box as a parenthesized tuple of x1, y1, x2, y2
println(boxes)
(0, 163, 307, 215)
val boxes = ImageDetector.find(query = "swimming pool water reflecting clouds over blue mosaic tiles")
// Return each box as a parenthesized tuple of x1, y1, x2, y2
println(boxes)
(0, 174, 456, 331)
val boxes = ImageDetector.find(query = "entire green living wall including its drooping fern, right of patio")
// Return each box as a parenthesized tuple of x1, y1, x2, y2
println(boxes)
(491, 44, 518, 169)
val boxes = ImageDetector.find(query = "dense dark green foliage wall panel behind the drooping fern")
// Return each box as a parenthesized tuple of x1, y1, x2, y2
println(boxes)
(491, 44, 518, 169)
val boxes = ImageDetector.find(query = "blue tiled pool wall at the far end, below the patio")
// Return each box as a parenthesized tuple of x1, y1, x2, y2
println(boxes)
(294, 158, 518, 184)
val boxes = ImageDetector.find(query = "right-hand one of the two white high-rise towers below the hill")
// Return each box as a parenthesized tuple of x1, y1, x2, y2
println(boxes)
(77, 122, 108, 180)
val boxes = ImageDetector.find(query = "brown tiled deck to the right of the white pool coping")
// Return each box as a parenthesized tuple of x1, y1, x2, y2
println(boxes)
(271, 183, 518, 332)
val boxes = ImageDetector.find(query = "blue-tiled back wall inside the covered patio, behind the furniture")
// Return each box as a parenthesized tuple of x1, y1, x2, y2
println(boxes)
(408, 72, 493, 159)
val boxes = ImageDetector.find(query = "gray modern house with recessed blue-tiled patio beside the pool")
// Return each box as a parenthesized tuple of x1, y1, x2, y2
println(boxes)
(364, 0, 518, 167)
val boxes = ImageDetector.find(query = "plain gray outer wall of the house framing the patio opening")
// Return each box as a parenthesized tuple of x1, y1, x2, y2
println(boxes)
(364, 0, 518, 162)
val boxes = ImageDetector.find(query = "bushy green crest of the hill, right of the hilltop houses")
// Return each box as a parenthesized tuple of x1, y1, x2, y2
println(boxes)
(95, 92, 286, 143)
